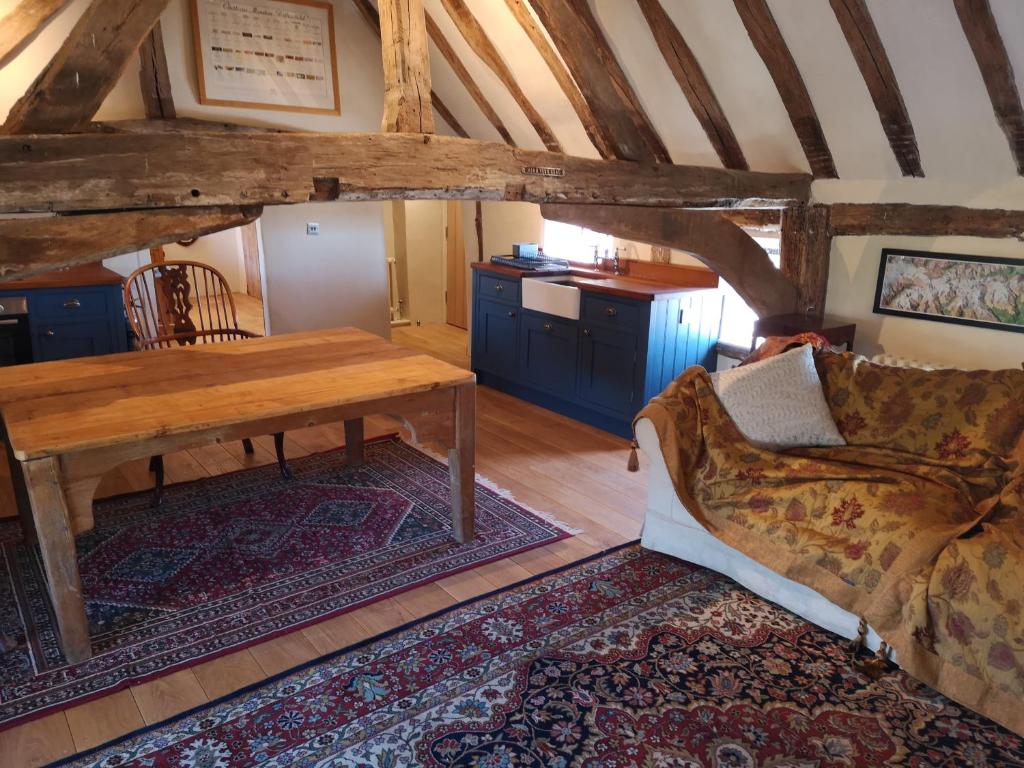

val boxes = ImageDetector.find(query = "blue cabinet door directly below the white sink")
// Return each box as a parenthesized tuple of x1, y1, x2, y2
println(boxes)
(519, 313, 578, 397)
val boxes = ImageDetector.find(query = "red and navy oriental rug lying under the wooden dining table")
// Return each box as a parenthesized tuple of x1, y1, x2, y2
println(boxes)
(0, 438, 571, 733)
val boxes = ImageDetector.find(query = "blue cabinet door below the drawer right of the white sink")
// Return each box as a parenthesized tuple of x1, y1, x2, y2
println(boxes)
(579, 325, 640, 417)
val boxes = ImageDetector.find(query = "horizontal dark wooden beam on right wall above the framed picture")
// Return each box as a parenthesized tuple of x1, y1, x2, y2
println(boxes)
(830, 203, 1024, 241)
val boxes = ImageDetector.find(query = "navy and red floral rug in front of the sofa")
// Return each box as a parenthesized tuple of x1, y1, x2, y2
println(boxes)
(54, 545, 1024, 768)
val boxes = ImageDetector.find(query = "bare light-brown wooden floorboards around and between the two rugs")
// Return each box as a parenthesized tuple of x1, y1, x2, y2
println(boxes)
(0, 323, 646, 768)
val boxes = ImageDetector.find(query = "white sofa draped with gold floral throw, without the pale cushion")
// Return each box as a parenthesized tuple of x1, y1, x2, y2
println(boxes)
(634, 351, 1024, 733)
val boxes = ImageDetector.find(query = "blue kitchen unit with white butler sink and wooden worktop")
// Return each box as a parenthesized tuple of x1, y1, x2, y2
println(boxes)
(471, 262, 722, 437)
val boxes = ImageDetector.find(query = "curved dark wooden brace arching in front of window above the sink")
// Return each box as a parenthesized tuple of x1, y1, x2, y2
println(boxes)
(541, 205, 798, 317)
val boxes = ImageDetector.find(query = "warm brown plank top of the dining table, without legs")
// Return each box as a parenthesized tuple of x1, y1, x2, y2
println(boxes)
(0, 328, 475, 461)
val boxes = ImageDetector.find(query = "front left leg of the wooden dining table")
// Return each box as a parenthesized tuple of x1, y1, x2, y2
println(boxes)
(22, 458, 92, 664)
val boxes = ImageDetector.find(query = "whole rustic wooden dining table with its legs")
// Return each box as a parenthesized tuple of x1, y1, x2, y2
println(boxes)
(0, 328, 476, 663)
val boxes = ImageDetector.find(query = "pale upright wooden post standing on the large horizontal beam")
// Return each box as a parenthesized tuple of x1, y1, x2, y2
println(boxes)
(379, 0, 434, 133)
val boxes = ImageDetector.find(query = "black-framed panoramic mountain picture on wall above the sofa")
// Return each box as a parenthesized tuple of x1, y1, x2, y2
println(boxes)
(874, 248, 1024, 333)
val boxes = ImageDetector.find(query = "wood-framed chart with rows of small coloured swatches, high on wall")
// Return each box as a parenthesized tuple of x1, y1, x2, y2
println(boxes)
(191, 0, 341, 115)
